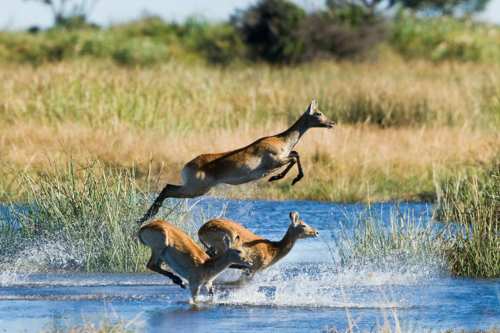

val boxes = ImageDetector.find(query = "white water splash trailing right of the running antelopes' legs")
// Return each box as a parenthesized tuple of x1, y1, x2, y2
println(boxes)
(214, 263, 440, 308)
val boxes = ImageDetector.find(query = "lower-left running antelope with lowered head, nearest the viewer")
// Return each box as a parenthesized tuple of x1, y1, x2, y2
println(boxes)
(139, 220, 251, 303)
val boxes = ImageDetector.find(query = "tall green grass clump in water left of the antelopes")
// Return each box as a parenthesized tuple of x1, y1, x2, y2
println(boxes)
(4, 164, 199, 272)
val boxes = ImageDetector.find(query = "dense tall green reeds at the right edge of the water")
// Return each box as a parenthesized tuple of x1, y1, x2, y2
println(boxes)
(436, 161, 500, 278)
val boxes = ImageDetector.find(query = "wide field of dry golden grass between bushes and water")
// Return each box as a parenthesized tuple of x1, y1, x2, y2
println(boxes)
(0, 58, 500, 201)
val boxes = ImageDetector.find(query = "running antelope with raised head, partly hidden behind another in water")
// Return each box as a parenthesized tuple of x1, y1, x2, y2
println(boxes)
(198, 212, 319, 279)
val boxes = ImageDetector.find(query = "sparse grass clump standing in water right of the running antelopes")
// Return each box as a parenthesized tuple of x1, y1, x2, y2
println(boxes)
(338, 209, 448, 270)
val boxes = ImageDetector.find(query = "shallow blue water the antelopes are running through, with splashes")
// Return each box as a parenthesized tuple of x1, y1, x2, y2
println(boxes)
(0, 199, 500, 332)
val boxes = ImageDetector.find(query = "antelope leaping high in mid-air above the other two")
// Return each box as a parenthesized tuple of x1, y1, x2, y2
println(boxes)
(137, 100, 335, 224)
